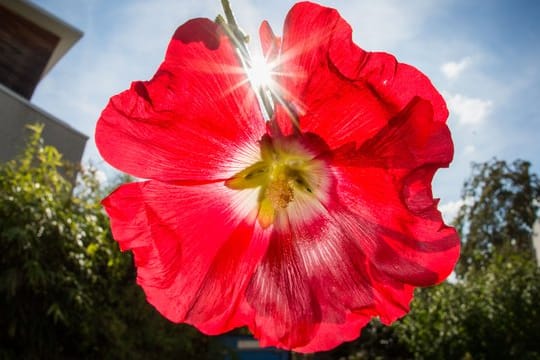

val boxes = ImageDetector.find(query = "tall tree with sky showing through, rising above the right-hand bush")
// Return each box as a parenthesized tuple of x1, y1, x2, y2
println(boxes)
(456, 159, 540, 276)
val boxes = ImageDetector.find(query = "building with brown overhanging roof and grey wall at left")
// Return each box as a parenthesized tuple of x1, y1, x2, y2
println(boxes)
(0, 0, 88, 163)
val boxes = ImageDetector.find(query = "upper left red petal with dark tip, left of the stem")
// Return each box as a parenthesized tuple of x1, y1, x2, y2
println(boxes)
(96, 19, 266, 181)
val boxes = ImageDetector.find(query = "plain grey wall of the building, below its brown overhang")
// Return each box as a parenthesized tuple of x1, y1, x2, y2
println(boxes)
(0, 84, 88, 164)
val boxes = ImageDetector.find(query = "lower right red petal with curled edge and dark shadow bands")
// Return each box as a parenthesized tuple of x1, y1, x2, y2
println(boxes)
(331, 166, 459, 286)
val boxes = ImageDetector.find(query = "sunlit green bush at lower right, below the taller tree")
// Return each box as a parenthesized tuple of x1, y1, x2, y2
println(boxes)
(396, 255, 540, 359)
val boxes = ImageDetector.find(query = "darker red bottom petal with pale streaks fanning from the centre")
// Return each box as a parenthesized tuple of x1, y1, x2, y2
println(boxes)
(246, 213, 375, 351)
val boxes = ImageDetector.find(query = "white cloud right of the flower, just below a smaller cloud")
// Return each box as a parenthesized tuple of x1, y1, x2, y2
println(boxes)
(444, 94, 493, 125)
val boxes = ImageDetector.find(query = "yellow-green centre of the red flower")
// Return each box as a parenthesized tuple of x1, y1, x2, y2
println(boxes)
(225, 135, 327, 228)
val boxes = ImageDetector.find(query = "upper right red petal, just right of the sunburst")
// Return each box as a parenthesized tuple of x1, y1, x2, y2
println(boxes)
(277, 3, 448, 148)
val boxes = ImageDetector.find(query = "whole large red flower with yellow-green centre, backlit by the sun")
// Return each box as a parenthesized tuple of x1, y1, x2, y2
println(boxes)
(96, 3, 459, 352)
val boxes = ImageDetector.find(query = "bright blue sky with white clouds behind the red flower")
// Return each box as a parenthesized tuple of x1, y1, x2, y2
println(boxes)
(33, 0, 540, 219)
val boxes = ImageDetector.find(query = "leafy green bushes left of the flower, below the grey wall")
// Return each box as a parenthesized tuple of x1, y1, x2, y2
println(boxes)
(0, 126, 224, 359)
